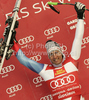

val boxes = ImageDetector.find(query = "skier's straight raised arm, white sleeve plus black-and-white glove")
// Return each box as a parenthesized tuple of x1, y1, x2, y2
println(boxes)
(70, 2, 85, 60)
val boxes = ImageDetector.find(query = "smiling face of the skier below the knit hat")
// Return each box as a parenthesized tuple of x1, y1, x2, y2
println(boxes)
(49, 50, 62, 65)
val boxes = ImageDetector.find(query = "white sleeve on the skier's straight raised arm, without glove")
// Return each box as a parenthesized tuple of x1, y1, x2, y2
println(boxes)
(70, 19, 84, 60)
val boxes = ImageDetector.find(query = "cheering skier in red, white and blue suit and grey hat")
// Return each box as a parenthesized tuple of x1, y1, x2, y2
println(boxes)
(13, 2, 85, 100)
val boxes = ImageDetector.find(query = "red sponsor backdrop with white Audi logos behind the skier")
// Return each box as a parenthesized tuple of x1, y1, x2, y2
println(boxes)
(0, 0, 89, 100)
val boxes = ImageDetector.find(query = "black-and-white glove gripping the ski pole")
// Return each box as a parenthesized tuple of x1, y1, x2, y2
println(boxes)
(74, 2, 85, 19)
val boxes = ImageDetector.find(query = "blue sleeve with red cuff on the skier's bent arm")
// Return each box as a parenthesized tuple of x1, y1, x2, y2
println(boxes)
(13, 43, 44, 74)
